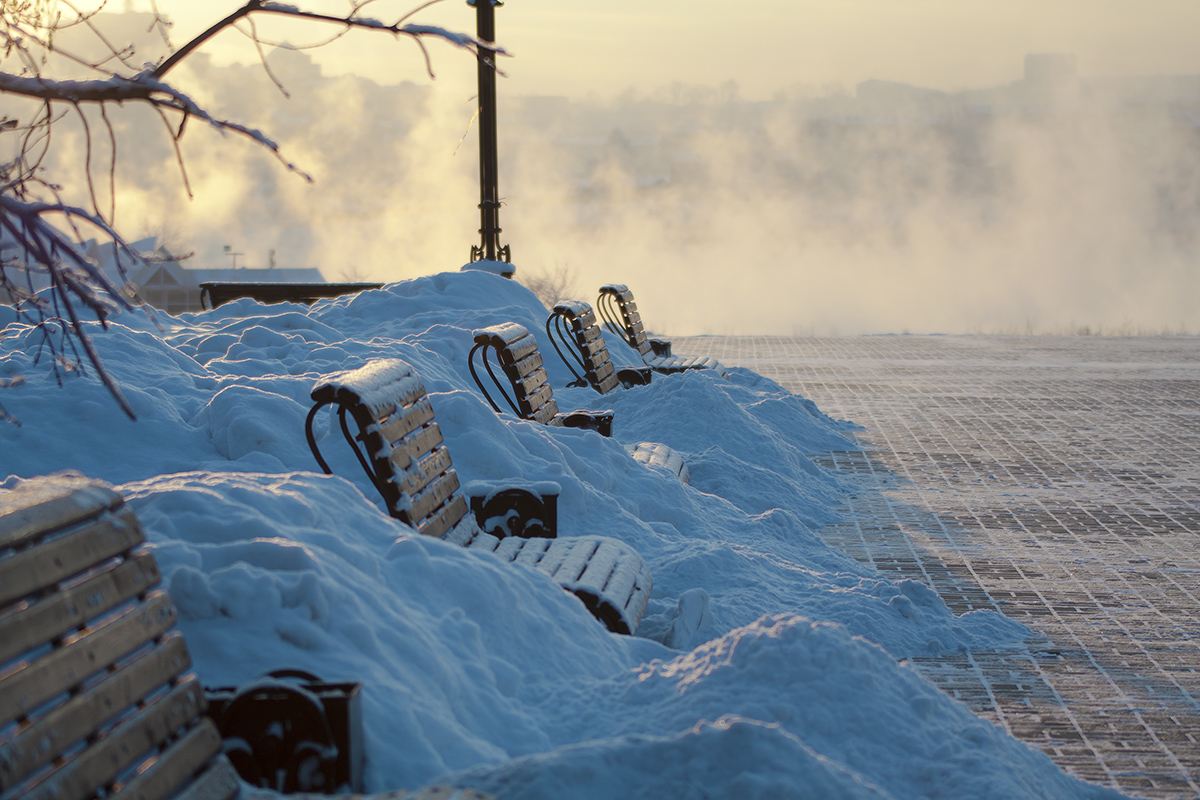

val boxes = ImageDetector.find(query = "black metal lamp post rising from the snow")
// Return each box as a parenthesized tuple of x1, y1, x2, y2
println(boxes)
(467, 0, 512, 261)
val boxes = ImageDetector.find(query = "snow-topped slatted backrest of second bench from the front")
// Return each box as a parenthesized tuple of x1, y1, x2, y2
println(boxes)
(307, 359, 467, 537)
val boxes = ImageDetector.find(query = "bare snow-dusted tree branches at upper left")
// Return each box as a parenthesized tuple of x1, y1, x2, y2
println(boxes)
(0, 0, 496, 421)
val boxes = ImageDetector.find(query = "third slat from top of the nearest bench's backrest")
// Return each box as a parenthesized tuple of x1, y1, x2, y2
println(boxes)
(0, 552, 162, 663)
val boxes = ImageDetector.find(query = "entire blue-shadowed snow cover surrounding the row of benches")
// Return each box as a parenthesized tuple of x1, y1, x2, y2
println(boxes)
(0, 271, 1121, 800)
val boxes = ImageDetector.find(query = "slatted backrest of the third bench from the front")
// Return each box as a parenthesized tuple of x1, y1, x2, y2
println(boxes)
(467, 323, 558, 425)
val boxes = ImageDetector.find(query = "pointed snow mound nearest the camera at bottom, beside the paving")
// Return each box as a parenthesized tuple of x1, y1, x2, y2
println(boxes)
(455, 614, 1122, 800)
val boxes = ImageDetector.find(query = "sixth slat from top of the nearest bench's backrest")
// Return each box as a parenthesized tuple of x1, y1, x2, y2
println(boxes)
(26, 679, 211, 800)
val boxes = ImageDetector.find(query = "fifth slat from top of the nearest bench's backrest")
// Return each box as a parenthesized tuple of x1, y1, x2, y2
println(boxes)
(0, 632, 191, 786)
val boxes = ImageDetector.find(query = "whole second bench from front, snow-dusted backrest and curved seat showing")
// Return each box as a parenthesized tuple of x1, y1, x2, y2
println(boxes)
(307, 359, 653, 633)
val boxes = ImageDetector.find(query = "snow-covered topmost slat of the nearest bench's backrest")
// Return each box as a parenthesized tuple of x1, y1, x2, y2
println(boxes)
(0, 475, 122, 549)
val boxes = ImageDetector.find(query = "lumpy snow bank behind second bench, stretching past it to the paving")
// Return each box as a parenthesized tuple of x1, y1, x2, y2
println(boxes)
(2, 272, 1026, 657)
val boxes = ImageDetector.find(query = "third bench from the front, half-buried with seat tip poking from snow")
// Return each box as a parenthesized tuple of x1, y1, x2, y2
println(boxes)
(468, 323, 689, 483)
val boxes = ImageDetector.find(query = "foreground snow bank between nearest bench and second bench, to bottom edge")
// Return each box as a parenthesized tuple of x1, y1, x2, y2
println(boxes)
(121, 471, 1108, 798)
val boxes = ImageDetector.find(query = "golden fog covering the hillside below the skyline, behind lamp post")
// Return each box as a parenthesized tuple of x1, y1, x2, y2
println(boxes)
(9, 15, 1200, 335)
